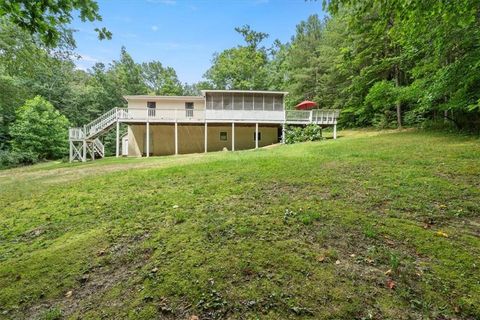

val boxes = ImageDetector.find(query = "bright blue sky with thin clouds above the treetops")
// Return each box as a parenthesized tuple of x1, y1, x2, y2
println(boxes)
(72, 0, 324, 83)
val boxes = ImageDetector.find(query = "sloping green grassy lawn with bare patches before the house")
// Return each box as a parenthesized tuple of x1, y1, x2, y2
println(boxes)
(0, 131, 480, 319)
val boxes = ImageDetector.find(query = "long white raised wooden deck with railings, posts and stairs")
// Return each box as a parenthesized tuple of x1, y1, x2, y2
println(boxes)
(69, 108, 339, 161)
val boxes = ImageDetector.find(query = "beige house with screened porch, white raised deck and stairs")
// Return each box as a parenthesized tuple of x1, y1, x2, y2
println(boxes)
(69, 90, 338, 161)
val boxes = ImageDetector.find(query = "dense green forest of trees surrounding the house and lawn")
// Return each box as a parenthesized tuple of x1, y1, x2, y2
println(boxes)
(0, 0, 480, 167)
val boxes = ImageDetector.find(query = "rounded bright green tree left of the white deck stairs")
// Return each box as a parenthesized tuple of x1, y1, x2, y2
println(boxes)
(10, 96, 69, 159)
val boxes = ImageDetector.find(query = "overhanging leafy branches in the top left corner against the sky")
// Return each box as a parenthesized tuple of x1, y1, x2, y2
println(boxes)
(0, 0, 112, 47)
